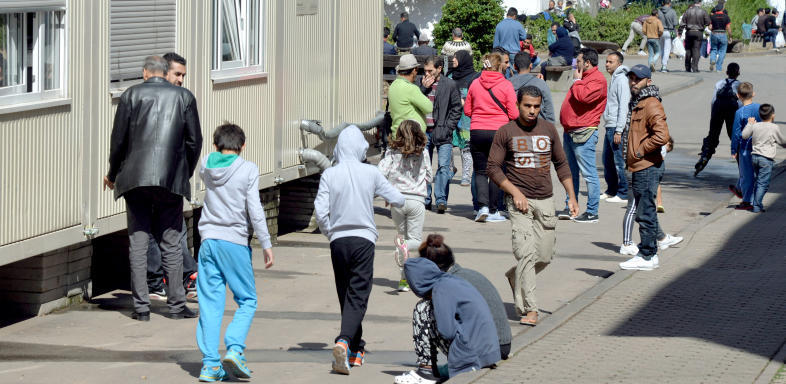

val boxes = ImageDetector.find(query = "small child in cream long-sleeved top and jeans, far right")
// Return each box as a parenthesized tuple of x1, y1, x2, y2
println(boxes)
(742, 104, 786, 212)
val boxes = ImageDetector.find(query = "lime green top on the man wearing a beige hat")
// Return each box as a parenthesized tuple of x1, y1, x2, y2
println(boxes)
(388, 77, 434, 137)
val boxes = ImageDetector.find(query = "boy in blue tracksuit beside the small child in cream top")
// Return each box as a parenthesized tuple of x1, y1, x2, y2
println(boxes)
(729, 82, 761, 211)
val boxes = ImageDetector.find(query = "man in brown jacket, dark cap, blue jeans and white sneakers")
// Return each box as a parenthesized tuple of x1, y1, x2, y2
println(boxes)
(620, 64, 669, 271)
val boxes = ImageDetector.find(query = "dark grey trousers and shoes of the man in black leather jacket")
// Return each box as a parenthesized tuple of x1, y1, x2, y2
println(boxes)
(123, 187, 186, 313)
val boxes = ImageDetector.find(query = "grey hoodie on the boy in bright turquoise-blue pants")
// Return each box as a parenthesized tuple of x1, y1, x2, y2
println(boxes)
(199, 152, 272, 249)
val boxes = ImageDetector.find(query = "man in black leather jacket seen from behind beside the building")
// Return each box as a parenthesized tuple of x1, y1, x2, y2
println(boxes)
(104, 56, 202, 321)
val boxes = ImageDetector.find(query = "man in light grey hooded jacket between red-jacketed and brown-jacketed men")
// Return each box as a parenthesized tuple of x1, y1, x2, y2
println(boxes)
(600, 52, 630, 203)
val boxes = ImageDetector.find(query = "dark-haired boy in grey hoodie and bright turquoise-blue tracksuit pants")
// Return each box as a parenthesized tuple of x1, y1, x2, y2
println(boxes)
(196, 123, 273, 382)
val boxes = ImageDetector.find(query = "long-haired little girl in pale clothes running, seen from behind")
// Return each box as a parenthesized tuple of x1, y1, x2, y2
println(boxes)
(379, 120, 431, 292)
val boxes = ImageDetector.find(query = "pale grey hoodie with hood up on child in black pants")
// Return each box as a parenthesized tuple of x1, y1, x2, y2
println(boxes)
(314, 125, 404, 243)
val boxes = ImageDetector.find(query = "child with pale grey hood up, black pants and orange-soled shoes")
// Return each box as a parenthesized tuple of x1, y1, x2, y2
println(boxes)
(314, 125, 404, 375)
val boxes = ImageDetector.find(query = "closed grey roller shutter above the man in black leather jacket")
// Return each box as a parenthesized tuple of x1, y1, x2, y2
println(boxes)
(109, 0, 177, 81)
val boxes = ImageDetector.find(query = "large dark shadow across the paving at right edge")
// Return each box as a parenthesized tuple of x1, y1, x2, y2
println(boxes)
(609, 168, 786, 358)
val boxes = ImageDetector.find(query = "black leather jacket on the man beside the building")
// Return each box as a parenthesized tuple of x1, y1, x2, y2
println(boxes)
(107, 77, 202, 199)
